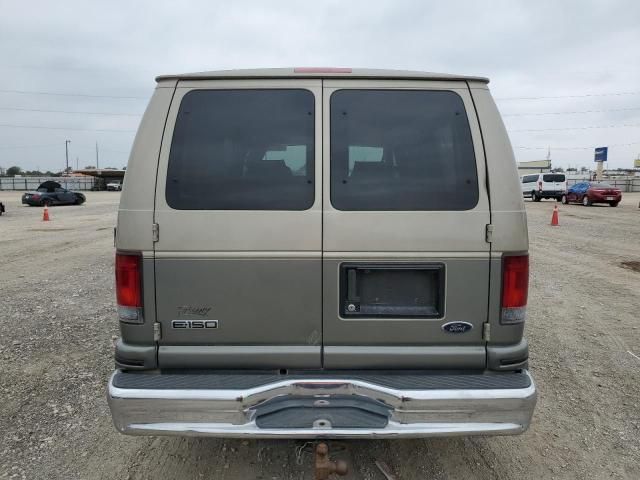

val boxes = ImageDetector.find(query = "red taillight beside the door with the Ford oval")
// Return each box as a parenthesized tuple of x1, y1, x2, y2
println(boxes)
(500, 255, 529, 324)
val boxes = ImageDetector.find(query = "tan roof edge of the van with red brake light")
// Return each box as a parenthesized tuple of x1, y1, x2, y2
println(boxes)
(156, 67, 489, 83)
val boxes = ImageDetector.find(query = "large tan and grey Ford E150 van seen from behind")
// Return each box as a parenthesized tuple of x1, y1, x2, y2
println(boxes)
(108, 69, 536, 438)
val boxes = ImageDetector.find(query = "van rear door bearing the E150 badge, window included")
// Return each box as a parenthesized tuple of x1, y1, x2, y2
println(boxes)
(155, 79, 322, 368)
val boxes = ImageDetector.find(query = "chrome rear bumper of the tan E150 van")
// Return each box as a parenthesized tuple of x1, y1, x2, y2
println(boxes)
(108, 371, 537, 438)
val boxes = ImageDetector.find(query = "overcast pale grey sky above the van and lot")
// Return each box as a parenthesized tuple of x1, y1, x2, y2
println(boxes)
(0, 0, 640, 171)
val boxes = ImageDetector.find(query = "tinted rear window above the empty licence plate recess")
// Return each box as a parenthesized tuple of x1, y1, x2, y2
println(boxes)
(330, 90, 478, 210)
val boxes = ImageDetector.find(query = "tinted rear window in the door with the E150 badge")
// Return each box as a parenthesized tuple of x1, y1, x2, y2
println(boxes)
(166, 90, 315, 210)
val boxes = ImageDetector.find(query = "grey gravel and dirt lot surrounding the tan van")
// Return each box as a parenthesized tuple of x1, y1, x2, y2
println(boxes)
(0, 192, 640, 480)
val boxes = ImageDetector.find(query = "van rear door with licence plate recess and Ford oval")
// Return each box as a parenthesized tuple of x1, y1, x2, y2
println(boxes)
(323, 80, 491, 369)
